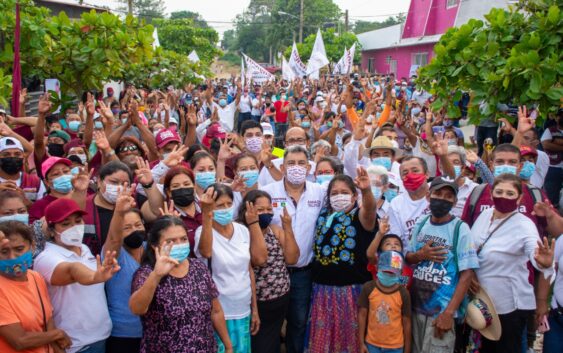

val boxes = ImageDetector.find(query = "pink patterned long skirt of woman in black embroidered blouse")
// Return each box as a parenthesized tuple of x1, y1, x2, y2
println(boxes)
(305, 283, 362, 353)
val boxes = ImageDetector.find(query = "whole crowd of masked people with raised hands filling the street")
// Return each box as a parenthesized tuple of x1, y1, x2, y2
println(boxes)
(0, 74, 563, 353)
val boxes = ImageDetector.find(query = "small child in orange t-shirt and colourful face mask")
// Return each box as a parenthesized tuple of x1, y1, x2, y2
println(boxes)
(358, 251, 411, 353)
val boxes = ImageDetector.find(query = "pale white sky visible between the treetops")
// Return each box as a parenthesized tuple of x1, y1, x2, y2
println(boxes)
(164, 0, 410, 36)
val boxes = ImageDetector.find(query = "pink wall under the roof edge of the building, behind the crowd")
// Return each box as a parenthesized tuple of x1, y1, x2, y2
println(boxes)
(362, 43, 436, 78)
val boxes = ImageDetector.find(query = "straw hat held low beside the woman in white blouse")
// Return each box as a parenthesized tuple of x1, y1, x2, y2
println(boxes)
(465, 288, 502, 341)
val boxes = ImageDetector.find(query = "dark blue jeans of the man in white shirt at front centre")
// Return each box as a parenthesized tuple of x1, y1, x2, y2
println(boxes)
(285, 269, 313, 353)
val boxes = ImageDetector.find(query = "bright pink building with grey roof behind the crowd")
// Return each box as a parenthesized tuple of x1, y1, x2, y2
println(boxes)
(358, 0, 514, 78)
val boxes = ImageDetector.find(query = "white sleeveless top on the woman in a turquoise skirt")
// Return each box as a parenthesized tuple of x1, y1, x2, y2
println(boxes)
(195, 222, 252, 320)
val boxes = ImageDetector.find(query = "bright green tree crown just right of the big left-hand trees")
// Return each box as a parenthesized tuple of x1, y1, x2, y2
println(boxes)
(152, 18, 221, 64)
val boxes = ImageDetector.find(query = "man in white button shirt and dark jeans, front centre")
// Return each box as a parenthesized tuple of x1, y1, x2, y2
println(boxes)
(263, 146, 326, 353)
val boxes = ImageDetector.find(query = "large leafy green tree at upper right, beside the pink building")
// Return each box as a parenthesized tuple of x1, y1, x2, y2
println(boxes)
(419, 0, 563, 124)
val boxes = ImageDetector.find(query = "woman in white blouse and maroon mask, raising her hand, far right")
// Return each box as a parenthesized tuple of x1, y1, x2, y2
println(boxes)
(471, 174, 553, 353)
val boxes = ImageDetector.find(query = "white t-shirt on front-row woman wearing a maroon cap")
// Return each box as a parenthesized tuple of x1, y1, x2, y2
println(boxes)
(33, 242, 112, 353)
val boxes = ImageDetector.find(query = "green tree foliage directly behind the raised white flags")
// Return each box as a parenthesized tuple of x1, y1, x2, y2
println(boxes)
(284, 28, 362, 63)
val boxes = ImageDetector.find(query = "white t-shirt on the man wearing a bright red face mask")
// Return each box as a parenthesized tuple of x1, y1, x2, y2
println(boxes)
(387, 192, 430, 248)
